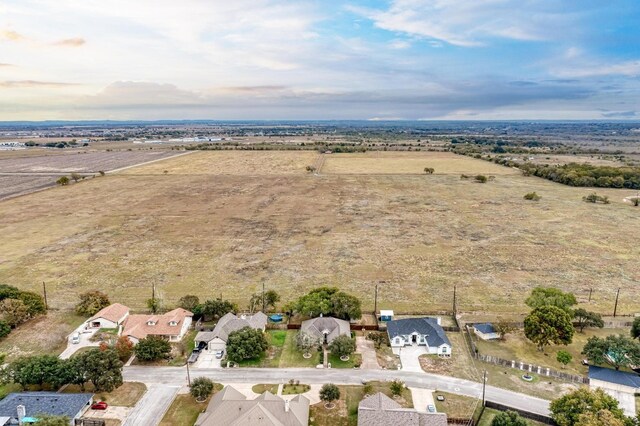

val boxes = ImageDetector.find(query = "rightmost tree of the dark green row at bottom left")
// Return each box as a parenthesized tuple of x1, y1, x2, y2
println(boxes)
(76, 349, 122, 392)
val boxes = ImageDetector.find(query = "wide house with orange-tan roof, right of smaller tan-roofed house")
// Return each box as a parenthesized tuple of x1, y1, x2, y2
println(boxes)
(122, 308, 193, 344)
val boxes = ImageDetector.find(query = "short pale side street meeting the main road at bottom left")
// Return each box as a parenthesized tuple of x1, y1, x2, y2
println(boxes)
(123, 382, 180, 426)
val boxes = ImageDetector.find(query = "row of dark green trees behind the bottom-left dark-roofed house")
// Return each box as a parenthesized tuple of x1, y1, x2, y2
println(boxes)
(2, 349, 122, 392)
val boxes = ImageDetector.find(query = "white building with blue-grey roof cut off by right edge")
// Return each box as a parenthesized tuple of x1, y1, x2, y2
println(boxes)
(589, 365, 640, 416)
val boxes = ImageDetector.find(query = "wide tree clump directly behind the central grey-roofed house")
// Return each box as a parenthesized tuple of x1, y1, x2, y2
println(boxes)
(294, 287, 362, 320)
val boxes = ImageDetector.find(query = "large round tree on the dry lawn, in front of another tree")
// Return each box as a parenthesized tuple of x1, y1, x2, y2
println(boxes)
(524, 306, 574, 351)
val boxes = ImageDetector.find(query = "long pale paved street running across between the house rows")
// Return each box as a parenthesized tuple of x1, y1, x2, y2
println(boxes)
(124, 366, 549, 416)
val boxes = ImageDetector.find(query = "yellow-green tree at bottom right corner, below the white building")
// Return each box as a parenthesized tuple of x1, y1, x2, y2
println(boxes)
(550, 388, 625, 426)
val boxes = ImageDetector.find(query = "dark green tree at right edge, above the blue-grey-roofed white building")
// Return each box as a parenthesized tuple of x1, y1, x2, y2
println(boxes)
(582, 334, 640, 370)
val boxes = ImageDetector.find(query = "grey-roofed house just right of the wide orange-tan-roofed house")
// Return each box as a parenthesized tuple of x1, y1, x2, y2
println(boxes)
(195, 312, 267, 352)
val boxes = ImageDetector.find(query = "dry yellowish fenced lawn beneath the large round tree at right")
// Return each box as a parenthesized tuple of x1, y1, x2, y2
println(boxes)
(474, 328, 629, 375)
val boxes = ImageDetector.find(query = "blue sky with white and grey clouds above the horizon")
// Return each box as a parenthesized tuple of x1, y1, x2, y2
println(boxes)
(0, 0, 640, 120)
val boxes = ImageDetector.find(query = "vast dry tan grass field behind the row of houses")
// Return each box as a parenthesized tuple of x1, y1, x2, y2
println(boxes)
(0, 151, 640, 314)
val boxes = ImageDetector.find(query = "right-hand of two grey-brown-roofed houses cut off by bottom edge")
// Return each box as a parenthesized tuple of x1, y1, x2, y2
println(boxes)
(358, 392, 447, 426)
